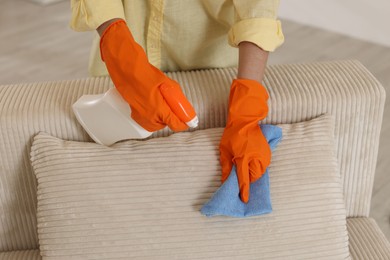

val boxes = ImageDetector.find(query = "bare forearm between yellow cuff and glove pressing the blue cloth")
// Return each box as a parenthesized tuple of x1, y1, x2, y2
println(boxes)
(237, 41, 268, 83)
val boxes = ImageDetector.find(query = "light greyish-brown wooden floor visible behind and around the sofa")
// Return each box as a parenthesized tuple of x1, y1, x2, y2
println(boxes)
(0, 0, 390, 239)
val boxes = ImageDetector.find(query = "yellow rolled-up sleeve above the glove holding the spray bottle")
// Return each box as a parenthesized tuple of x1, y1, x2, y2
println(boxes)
(70, 0, 125, 31)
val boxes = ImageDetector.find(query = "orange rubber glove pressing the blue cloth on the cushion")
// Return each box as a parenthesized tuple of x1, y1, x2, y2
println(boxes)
(219, 79, 271, 203)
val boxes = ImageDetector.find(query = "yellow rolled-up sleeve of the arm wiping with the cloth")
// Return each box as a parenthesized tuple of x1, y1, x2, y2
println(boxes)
(228, 0, 284, 52)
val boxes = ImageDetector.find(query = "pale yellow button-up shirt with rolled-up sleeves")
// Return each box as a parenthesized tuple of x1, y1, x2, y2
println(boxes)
(70, 0, 284, 76)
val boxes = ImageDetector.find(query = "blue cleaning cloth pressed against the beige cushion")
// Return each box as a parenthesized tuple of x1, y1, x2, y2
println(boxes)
(201, 125, 282, 218)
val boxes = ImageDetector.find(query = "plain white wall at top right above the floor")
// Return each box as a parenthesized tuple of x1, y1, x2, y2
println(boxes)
(279, 0, 390, 47)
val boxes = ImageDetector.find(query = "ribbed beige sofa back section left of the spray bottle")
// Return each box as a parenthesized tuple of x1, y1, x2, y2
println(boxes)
(0, 78, 109, 251)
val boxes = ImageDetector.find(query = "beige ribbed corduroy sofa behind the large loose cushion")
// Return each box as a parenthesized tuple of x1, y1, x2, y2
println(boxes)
(0, 61, 390, 259)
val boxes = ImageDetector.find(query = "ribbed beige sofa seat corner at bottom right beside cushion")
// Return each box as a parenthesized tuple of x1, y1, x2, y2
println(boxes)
(347, 218, 390, 260)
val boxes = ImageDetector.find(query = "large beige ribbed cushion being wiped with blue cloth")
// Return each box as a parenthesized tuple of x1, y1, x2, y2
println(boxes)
(31, 116, 349, 259)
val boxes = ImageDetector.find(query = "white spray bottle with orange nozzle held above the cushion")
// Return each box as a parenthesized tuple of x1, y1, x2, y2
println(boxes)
(72, 85, 198, 146)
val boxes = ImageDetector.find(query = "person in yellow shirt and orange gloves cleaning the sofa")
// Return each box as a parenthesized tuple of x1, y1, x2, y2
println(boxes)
(71, 0, 284, 202)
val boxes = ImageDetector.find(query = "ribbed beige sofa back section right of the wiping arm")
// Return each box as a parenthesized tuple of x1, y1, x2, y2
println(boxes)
(265, 61, 386, 217)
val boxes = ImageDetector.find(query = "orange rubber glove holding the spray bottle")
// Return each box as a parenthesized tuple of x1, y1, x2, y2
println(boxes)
(100, 20, 195, 132)
